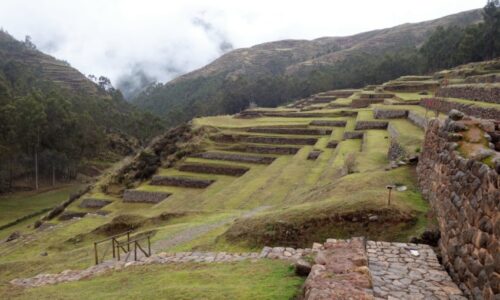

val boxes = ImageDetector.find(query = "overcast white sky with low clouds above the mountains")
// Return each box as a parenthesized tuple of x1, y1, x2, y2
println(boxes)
(0, 0, 486, 94)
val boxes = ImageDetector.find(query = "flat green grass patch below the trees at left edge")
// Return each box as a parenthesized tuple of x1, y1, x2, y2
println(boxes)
(0, 184, 82, 226)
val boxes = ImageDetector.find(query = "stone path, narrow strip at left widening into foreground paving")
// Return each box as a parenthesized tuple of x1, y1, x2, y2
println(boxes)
(10, 238, 466, 300)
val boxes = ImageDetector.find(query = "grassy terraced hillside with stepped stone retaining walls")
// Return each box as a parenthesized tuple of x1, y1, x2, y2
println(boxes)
(0, 60, 500, 299)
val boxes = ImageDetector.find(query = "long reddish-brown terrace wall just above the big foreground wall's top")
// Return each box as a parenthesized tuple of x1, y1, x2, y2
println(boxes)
(420, 98, 500, 120)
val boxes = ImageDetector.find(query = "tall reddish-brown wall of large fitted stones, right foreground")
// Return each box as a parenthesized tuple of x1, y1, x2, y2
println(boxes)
(417, 119, 500, 299)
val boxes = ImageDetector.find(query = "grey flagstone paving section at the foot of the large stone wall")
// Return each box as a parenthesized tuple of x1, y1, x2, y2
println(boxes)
(366, 241, 467, 300)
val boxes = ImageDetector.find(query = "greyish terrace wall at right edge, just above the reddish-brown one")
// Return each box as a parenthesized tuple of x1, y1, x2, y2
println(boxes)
(436, 85, 500, 104)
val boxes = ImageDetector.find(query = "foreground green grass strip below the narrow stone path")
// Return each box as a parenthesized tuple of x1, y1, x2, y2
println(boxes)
(3, 260, 304, 300)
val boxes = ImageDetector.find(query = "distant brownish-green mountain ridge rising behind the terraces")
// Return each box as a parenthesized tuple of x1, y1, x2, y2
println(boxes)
(133, 10, 482, 125)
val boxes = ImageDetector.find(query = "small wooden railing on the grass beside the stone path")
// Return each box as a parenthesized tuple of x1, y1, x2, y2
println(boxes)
(94, 230, 151, 265)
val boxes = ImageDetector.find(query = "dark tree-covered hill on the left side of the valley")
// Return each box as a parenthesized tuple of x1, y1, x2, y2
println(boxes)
(0, 31, 164, 192)
